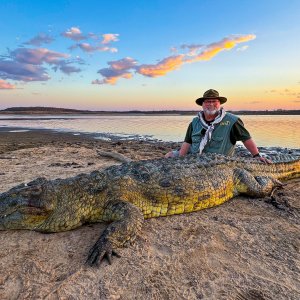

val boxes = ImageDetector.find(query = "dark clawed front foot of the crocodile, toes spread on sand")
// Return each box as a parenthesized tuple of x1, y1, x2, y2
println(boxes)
(86, 238, 121, 266)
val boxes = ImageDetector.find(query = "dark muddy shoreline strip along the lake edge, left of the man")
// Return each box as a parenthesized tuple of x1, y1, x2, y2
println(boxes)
(0, 127, 179, 160)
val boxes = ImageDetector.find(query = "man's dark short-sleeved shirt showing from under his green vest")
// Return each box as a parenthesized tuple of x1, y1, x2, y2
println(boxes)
(184, 118, 251, 145)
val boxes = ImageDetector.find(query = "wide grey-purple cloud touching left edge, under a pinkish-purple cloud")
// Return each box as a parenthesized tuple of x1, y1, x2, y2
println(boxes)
(0, 60, 50, 82)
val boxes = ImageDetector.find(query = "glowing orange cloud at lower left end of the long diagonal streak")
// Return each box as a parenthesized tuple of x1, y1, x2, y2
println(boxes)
(136, 54, 185, 77)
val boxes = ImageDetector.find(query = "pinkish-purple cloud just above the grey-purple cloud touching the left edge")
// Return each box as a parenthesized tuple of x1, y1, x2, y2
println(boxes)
(10, 48, 70, 65)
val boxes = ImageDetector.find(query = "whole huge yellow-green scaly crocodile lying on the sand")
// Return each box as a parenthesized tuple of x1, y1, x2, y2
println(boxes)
(0, 154, 300, 266)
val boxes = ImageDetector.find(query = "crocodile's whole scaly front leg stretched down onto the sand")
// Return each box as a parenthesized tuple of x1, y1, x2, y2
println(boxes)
(86, 201, 144, 266)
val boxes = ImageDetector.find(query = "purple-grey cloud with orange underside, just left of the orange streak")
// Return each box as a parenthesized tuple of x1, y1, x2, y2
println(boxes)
(92, 57, 137, 84)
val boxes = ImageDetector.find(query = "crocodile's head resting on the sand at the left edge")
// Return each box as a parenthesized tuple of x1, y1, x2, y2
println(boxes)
(0, 178, 56, 230)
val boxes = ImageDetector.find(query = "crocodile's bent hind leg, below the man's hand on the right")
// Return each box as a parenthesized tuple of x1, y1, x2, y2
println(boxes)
(234, 168, 282, 197)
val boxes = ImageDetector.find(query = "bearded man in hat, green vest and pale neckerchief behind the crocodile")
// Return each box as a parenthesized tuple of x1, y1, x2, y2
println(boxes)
(165, 89, 270, 163)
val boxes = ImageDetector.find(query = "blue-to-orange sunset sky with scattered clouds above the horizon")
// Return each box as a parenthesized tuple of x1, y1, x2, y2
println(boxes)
(0, 0, 300, 111)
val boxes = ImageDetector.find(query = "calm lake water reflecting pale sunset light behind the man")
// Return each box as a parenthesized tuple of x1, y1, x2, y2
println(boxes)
(0, 115, 300, 148)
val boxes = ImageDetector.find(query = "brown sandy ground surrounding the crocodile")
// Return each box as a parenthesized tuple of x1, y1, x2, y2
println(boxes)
(0, 131, 300, 300)
